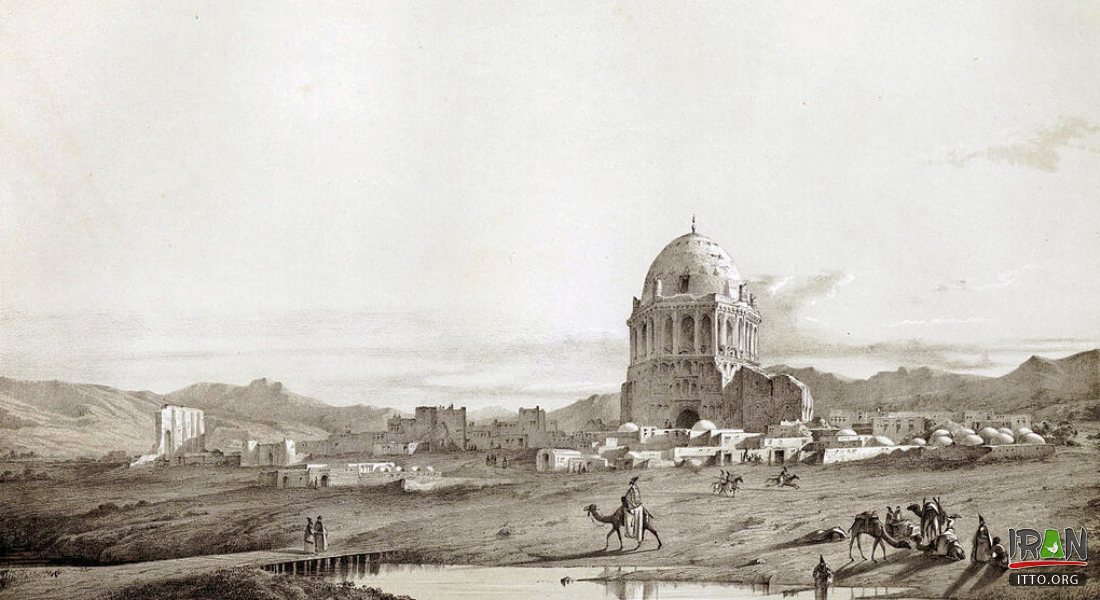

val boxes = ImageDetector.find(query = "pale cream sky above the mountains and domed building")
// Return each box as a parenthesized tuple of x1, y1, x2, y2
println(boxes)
(0, 1, 1100, 410)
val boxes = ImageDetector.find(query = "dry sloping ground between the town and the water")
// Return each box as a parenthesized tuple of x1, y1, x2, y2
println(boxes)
(0, 424, 1100, 598)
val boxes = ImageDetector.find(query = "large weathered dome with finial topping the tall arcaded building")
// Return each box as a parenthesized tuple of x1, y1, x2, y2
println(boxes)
(641, 231, 741, 302)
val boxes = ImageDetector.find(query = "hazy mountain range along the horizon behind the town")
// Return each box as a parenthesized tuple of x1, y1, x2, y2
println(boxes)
(0, 350, 1100, 457)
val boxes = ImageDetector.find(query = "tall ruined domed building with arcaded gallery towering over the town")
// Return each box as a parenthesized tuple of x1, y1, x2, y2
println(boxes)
(620, 225, 813, 432)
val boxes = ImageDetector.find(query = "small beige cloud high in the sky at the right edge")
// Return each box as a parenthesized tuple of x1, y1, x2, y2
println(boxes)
(947, 117, 1100, 173)
